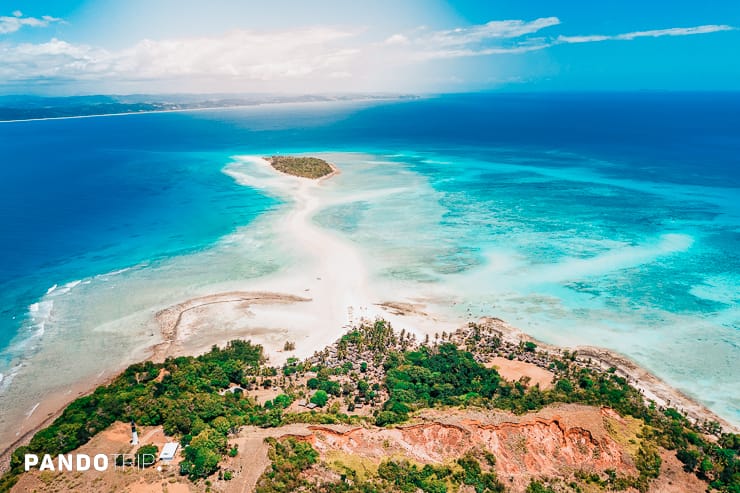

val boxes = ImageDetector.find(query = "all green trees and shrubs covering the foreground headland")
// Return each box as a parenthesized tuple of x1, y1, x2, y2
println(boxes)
(0, 320, 740, 493)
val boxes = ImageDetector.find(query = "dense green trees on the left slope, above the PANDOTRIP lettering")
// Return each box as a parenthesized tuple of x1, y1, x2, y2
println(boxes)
(0, 341, 281, 491)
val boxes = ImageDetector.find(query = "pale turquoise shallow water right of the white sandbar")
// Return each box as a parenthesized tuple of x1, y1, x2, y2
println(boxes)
(318, 153, 740, 421)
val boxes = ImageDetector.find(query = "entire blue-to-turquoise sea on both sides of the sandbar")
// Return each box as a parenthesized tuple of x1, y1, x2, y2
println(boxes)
(0, 94, 740, 430)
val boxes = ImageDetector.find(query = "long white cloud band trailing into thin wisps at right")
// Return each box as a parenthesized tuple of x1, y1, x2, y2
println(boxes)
(0, 12, 734, 92)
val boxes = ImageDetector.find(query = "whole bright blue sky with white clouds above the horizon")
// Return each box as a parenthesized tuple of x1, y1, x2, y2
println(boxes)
(0, 0, 740, 94)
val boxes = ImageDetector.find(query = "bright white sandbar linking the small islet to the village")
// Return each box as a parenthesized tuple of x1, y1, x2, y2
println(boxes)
(210, 157, 457, 363)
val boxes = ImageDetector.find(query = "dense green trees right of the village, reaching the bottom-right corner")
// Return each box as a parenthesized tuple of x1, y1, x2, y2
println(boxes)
(372, 324, 740, 493)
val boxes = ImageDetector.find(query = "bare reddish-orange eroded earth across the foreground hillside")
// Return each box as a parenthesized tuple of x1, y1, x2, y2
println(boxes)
(12, 404, 706, 493)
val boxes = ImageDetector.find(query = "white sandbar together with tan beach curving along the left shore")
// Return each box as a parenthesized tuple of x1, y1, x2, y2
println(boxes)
(0, 156, 459, 460)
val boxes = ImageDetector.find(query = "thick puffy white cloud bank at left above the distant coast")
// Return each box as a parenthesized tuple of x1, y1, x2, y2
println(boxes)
(0, 28, 357, 81)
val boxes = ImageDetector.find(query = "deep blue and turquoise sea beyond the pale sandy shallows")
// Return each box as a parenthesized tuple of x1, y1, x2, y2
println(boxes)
(0, 93, 740, 418)
